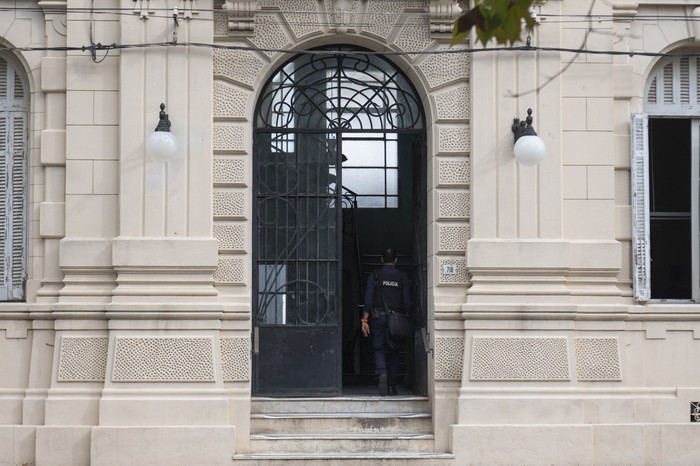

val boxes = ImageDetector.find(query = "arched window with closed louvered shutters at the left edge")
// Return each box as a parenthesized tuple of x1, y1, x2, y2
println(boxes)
(0, 55, 29, 301)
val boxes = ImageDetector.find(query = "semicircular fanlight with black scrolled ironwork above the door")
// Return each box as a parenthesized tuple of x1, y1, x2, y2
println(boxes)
(255, 46, 425, 132)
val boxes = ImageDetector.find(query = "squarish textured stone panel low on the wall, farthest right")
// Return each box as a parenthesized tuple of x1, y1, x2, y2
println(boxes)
(574, 338, 622, 381)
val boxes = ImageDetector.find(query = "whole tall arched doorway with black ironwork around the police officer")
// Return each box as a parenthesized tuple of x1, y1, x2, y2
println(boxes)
(253, 46, 426, 395)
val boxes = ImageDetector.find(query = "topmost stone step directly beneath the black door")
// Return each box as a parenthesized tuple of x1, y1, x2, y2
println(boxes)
(251, 396, 430, 414)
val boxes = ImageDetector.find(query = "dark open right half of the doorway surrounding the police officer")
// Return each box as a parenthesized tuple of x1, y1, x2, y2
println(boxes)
(342, 133, 426, 394)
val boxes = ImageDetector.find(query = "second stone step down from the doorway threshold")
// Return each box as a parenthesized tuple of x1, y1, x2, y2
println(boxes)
(250, 413, 432, 434)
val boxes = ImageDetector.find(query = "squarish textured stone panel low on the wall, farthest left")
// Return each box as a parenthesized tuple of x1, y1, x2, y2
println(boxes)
(58, 337, 109, 382)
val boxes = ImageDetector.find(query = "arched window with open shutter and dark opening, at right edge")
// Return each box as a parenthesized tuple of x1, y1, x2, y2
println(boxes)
(632, 56, 700, 302)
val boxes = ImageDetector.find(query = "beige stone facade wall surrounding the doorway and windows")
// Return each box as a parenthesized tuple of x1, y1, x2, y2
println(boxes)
(0, 0, 700, 464)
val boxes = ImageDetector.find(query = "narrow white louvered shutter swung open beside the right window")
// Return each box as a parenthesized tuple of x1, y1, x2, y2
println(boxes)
(631, 113, 651, 301)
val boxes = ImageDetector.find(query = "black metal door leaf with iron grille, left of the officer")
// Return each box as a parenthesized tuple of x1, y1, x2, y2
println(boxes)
(253, 133, 341, 396)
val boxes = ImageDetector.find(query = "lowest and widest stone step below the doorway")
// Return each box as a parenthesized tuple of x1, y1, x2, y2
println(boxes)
(233, 452, 455, 466)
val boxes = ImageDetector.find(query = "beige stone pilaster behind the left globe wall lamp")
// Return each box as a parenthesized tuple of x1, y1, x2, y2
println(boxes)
(112, 0, 218, 307)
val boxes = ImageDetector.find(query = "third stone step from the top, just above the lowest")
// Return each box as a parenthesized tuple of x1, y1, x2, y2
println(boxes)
(250, 433, 435, 453)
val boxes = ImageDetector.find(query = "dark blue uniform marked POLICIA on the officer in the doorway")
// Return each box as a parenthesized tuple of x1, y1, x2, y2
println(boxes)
(365, 265, 411, 387)
